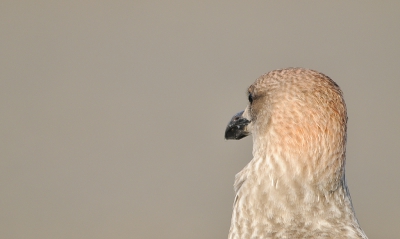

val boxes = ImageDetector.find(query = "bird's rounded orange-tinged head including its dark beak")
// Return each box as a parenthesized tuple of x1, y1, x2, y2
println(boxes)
(225, 68, 347, 183)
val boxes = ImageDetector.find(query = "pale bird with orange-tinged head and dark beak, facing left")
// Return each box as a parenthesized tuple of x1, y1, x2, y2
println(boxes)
(225, 68, 367, 239)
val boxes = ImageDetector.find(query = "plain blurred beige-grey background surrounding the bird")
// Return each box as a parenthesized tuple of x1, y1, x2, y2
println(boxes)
(0, 1, 400, 239)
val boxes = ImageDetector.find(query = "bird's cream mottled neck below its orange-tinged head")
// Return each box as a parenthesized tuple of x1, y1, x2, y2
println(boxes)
(232, 151, 362, 238)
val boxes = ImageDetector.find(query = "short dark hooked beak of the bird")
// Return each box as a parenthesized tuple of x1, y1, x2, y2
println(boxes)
(225, 111, 250, 140)
